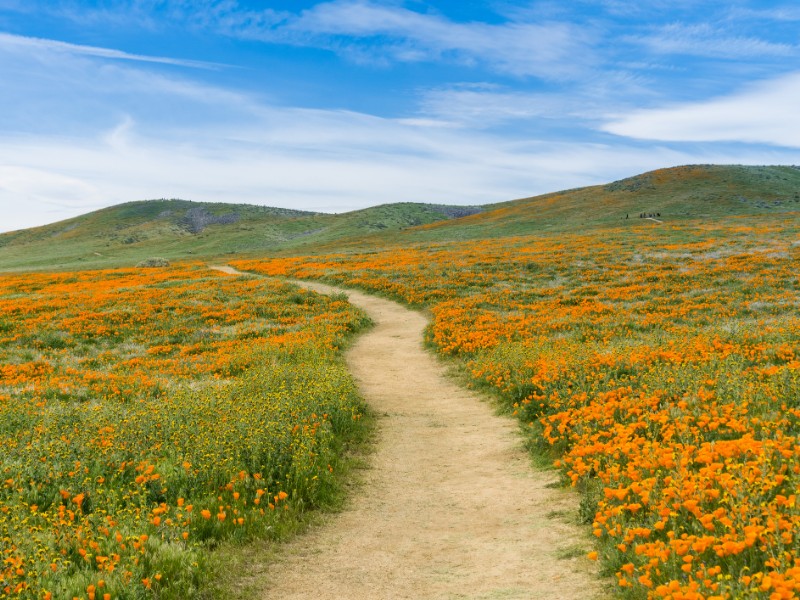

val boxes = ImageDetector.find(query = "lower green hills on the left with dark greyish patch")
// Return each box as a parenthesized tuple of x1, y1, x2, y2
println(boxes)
(0, 200, 482, 269)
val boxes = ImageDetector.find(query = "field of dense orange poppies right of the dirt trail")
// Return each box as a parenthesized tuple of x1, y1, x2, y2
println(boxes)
(235, 214, 800, 600)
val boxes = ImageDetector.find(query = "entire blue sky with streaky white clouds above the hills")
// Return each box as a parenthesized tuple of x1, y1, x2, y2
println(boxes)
(0, 0, 800, 231)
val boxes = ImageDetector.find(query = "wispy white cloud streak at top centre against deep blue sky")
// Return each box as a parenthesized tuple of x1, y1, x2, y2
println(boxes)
(236, 0, 591, 79)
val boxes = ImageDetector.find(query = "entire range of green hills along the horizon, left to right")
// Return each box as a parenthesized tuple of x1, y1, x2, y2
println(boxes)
(0, 165, 800, 269)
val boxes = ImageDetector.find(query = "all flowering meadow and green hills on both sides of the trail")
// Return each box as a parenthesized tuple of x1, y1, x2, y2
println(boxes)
(0, 166, 800, 600)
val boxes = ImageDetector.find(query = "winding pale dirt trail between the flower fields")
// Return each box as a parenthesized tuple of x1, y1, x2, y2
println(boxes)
(209, 269, 603, 600)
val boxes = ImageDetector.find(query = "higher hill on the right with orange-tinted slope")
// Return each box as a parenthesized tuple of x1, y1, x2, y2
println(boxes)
(398, 165, 800, 239)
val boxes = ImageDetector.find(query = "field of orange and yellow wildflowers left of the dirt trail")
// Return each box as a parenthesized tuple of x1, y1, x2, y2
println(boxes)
(0, 265, 365, 600)
